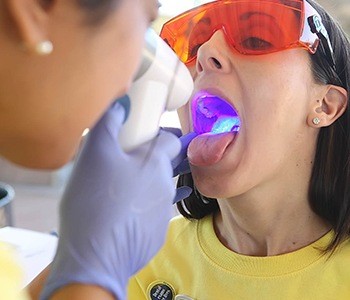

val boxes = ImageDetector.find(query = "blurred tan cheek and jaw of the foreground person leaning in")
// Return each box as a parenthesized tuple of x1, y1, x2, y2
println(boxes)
(0, 0, 157, 168)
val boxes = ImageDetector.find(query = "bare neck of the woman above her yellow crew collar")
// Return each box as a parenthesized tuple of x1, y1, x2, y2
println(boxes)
(214, 185, 330, 256)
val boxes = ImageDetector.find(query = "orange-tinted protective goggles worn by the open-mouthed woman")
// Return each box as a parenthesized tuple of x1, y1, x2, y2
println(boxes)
(160, 0, 334, 66)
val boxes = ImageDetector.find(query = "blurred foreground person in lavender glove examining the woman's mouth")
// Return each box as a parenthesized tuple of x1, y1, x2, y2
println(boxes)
(0, 0, 191, 300)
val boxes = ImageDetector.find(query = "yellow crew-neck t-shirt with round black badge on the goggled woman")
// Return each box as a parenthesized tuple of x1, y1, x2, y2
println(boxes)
(128, 217, 350, 300)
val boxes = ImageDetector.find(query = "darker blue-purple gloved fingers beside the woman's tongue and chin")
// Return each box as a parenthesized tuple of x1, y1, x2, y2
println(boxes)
(162, 127, 197, 203)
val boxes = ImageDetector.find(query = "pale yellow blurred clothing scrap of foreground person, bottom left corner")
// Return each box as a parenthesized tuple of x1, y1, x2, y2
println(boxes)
(0, 243, 29, 300)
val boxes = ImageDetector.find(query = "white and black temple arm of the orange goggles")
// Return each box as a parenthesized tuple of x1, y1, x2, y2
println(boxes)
(307, 15, 336, 70)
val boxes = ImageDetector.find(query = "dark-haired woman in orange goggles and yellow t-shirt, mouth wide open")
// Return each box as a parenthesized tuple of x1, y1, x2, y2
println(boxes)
(128, 0, 350, 300)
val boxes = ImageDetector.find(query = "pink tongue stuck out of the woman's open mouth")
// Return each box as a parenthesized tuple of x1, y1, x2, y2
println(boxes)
(187, 132, 237, 166)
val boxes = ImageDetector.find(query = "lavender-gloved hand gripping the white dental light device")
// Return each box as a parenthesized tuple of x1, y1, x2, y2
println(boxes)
(41, 103, 189, 299)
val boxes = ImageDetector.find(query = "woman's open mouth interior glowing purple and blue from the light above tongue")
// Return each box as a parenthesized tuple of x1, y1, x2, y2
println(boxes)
(192, 92, 241, 134)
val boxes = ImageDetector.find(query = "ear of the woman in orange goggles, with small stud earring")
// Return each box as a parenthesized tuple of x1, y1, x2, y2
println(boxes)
(308, 85, 348, 128)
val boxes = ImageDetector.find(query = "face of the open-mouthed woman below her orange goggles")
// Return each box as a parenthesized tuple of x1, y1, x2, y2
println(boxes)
(179, 31, 317, 198)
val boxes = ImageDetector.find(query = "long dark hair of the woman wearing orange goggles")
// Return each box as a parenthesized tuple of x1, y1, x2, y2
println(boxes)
(177, 0, 350, 251)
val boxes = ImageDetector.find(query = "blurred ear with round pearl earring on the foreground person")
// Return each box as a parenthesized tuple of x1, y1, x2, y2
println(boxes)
(5, 0, 52, 54)
